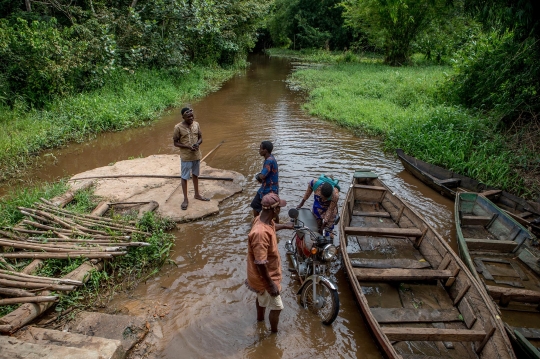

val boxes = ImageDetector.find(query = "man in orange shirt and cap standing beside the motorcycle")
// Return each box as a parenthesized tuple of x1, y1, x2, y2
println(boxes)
(246, 193, 293, 333)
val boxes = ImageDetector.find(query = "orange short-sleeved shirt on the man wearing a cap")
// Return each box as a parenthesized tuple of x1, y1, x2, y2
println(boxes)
(245, 217, 282, 294)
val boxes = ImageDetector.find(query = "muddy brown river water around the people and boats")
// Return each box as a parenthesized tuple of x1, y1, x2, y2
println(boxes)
(10, 56, 456, 358)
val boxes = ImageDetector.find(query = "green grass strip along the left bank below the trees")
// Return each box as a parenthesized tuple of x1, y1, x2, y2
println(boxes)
(0, 67, 236, 180)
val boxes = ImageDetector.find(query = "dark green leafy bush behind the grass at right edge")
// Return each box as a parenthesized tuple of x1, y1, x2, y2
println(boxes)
(445, 31, 540, 119)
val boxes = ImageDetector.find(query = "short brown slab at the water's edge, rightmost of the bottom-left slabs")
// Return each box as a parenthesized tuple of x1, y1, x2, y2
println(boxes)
(71, 312, 148, 351)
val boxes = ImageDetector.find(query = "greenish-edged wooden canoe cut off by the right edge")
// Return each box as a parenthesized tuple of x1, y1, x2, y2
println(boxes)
(455, 192, 540, 359)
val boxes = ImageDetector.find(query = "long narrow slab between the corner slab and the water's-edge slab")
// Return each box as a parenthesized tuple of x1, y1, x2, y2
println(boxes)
(17, 327, 126, 359)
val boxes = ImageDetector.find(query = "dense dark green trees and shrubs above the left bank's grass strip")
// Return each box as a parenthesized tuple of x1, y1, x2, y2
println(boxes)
(0, 0, 269, 106)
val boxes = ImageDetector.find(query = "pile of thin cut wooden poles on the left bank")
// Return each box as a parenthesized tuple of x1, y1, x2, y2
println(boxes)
(0, 199, 150, 305)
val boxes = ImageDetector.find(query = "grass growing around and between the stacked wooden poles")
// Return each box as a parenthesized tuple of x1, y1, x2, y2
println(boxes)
(0, 182, 175, 317)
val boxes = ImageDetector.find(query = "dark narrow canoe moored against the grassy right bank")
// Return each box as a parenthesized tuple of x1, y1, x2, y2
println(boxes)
(396, 148, 540, 235)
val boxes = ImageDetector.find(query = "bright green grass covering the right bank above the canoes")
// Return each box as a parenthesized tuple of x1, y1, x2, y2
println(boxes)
(269, 49, 540, 197)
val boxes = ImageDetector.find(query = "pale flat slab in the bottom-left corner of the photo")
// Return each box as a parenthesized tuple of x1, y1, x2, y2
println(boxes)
(0, 335, 100, 359)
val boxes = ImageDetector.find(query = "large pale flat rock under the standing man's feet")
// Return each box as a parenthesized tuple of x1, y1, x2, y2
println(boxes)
(71, 155, 245, 222)
